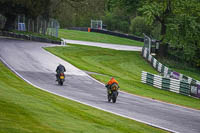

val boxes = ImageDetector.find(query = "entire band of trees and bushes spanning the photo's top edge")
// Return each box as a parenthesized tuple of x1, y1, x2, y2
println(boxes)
(0, 0, 200, 67)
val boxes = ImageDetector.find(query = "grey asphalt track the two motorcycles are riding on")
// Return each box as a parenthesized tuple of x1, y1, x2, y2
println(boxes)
(0, 37, 200, 133)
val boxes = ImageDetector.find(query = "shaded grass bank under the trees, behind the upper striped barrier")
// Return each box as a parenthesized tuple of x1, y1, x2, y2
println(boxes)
(158, 58, 200, 81)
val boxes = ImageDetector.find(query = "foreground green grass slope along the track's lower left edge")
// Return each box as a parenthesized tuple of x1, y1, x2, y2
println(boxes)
(0, 62, 165, 133)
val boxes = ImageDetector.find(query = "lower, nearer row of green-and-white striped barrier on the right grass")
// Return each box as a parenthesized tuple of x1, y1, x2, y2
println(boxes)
(141, 71, 191, 97)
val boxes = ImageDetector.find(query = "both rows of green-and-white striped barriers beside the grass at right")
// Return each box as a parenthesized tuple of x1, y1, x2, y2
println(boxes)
(142, 35, 200, 98)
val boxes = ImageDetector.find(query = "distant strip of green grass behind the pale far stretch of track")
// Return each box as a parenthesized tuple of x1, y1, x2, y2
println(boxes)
(58, 29, 144, 46)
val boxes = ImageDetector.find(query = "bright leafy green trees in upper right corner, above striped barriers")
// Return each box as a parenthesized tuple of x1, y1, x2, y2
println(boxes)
(139, 0, 200, 66)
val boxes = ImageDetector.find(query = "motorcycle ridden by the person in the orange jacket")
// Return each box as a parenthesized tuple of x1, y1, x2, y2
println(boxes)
(107, 83, 119, 103)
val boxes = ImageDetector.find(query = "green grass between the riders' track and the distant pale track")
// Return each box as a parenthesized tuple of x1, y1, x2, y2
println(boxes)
(46, 45, 200, 109)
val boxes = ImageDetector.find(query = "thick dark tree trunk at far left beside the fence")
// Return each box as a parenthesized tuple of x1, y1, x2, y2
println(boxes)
(4, 14, 16, 31)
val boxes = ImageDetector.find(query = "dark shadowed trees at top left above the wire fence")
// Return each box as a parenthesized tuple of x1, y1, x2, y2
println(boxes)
(0, 0, 85, 30)
